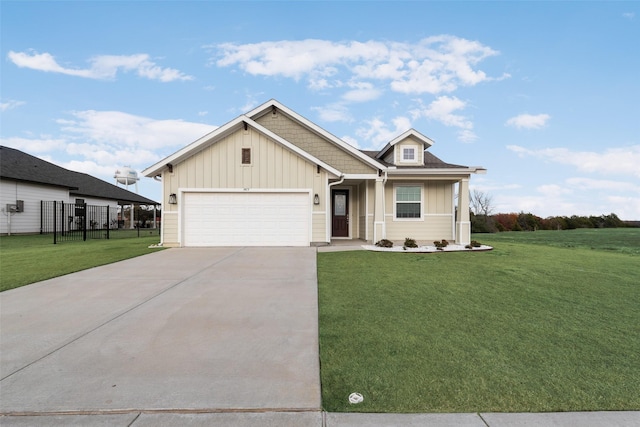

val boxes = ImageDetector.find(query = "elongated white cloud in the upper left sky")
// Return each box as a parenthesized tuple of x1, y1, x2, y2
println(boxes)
(7, 51, 193, 82)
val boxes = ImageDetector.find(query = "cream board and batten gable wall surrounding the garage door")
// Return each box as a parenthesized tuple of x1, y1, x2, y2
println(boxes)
(162, 128, 327, 246)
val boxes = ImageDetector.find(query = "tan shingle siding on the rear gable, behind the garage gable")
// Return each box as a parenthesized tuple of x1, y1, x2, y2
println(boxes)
(256, 111, 376, 173)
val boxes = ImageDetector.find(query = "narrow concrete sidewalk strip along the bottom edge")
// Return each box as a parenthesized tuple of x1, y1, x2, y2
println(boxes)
(0, 411, 640, 427)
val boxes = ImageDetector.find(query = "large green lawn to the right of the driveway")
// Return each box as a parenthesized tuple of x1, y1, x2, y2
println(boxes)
(318, 229, 640, 412)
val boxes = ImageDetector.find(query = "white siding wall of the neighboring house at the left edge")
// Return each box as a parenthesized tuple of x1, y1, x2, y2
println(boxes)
(0, 179, 69, 234)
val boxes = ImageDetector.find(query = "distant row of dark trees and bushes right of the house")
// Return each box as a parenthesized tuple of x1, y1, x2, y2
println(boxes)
(469, 190, 640, 233)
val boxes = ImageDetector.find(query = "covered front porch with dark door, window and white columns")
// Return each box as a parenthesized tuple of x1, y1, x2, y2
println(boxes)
(326, 173, 471, 245)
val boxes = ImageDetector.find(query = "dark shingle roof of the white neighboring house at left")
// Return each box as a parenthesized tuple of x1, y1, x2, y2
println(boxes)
(0, 146, 158, 205)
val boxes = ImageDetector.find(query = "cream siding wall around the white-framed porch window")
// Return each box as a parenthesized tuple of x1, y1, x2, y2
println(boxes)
(385, 180, 455, 242)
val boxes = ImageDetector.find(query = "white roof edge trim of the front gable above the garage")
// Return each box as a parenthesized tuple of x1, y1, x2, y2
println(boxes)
(142, 115, 342, 177)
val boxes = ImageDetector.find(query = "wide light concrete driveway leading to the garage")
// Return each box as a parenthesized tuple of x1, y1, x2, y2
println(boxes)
(0, 248, 321, 421)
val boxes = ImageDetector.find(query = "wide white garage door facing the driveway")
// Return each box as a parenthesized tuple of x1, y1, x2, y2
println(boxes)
(183, 192, 311, 246)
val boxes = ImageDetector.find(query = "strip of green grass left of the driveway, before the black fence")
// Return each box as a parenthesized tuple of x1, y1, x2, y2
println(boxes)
(0, 229, 160, 291)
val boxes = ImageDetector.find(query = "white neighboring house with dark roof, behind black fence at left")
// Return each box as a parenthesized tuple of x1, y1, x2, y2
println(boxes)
(0, 146, 157, 234)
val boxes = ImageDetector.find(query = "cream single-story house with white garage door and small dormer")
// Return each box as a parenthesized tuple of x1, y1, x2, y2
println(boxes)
(142, 100, 485, 246)
